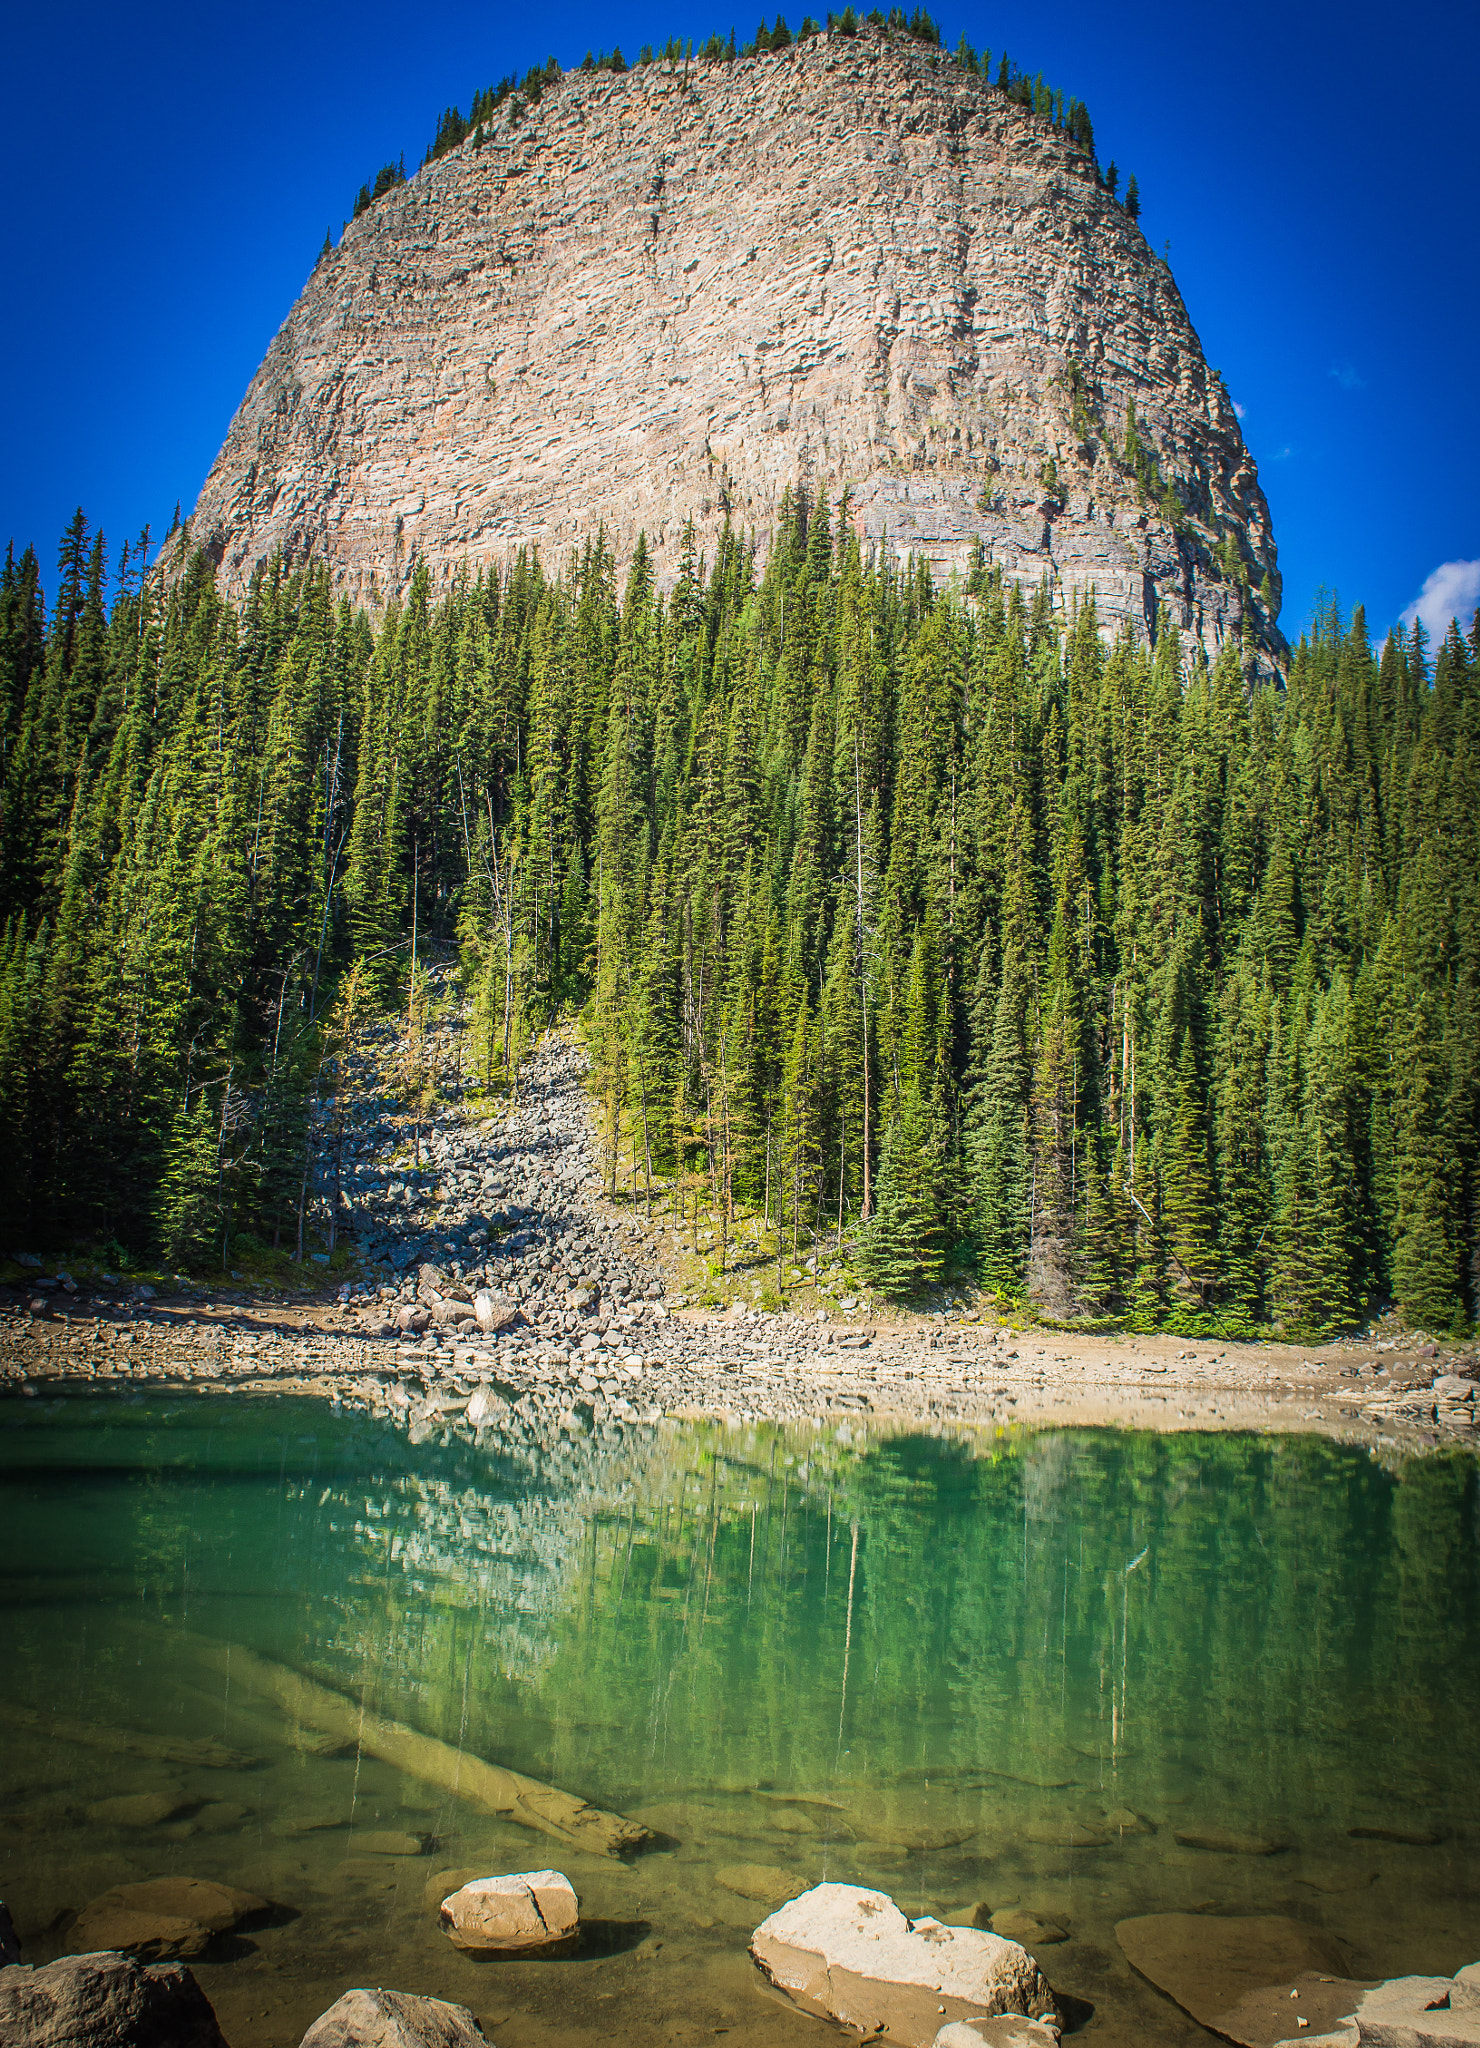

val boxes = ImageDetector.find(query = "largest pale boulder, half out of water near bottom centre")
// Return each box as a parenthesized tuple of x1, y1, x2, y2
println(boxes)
(751, 1884, 1054, 2048)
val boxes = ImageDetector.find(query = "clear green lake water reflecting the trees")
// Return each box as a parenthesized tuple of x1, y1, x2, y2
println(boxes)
(0, 1395, 1480, 2048)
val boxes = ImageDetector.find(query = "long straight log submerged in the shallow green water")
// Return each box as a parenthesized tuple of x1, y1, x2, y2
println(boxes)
(199, 1642, 657, 1858)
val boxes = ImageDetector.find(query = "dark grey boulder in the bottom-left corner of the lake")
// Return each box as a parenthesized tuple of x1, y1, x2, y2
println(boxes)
(0, 1954, 227, 2048)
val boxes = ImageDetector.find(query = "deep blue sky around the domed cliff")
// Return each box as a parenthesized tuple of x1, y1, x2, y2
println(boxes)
(0, 0, 1480, 637)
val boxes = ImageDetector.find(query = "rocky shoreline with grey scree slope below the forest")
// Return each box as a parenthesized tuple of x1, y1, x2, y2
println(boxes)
(0, 1007, 1480, 1456)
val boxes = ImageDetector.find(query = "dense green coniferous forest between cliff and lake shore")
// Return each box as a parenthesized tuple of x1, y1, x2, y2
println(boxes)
(0, 498, 1480, 1333)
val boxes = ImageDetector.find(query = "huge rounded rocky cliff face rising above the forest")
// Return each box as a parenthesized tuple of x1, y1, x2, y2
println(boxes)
(177, 35, 1281, 659)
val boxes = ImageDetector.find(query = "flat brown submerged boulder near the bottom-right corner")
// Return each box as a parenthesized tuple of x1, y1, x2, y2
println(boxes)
(1116, 1913, 1361, 2048)
